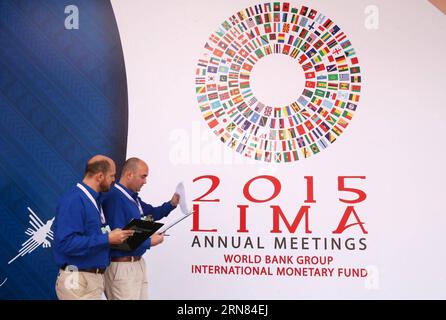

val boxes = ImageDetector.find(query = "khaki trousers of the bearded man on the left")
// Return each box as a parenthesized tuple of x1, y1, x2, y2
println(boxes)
(56, 270, 104, 300)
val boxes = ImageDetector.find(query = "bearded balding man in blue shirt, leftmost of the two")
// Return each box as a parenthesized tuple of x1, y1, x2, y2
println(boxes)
(53, 155, 133, 300)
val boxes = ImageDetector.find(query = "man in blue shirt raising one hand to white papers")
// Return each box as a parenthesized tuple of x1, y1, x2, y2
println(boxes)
(102, 158, 179, 300)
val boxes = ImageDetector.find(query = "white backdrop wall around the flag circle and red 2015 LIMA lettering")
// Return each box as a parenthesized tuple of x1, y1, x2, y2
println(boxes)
(112, 0, 446, 299)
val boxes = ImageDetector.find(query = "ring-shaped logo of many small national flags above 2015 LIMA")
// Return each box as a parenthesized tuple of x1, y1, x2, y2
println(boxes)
(195, 2, 361, 162)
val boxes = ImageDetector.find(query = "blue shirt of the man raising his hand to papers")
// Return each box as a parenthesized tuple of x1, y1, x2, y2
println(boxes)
(102, 183, 175, 257)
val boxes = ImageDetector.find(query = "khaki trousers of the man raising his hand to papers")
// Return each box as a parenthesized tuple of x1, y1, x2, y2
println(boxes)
(105, 258, 149, 300)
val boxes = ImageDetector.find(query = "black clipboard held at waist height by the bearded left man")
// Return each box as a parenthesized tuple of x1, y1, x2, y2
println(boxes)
(110, 219, 164, 251)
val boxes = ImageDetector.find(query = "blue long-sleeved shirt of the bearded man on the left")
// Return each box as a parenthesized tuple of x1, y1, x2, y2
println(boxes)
(53, 183, 110, 269)
